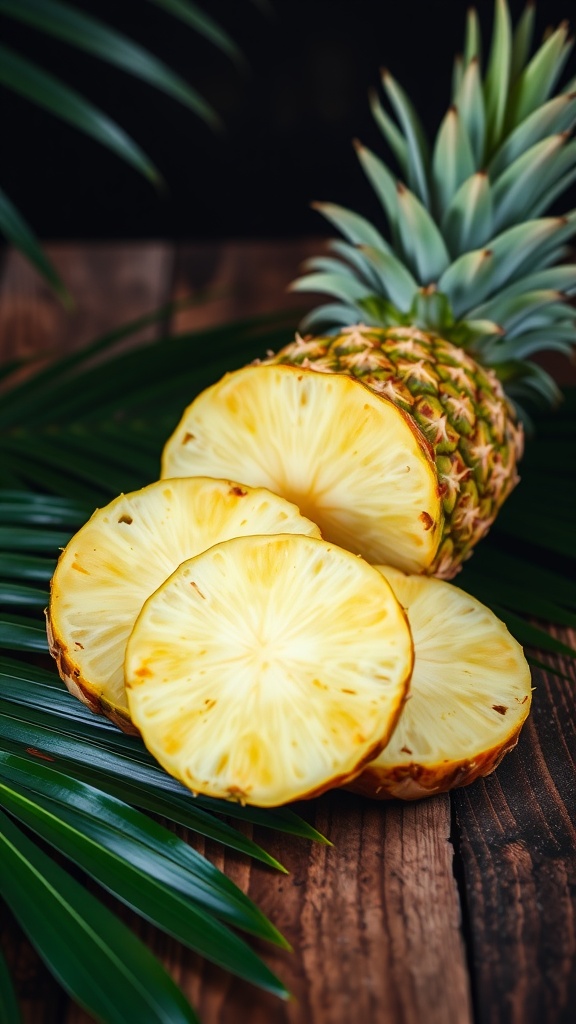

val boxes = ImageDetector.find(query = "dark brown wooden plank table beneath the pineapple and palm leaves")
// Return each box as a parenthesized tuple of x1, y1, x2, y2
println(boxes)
(0, 240, 576, 1024)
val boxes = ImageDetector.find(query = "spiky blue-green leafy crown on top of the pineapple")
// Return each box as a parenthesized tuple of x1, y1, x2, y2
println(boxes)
(292, 0, 576, 412)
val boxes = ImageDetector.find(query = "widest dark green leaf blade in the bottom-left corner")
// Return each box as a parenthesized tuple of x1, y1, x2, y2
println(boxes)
(0, 811, 198, 1024)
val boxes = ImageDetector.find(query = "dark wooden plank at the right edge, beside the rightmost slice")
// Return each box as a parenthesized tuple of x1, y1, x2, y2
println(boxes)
(453, 633, 576, 1024)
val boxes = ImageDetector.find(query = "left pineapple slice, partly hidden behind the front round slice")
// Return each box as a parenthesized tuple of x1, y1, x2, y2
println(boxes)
(47, 477, 320, 732)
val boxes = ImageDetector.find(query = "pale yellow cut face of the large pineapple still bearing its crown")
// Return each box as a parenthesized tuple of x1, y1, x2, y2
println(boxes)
(162, 365, 444, 572)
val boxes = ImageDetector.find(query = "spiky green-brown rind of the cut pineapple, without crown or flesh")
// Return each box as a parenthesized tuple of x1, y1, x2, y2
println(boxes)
(265, 325, 524, 580)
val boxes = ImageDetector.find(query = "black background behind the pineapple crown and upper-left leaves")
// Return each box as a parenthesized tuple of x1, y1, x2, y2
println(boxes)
(0, 0, 576, 240)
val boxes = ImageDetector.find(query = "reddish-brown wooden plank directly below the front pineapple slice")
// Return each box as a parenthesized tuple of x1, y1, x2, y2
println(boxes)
(112, 792, 472, 1024)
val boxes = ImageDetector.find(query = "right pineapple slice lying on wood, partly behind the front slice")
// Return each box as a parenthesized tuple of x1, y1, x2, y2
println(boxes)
(344, 566, 532, 800)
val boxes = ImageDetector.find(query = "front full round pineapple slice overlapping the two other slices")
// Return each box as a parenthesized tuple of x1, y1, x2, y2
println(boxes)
(125, 536, 413, 807)
